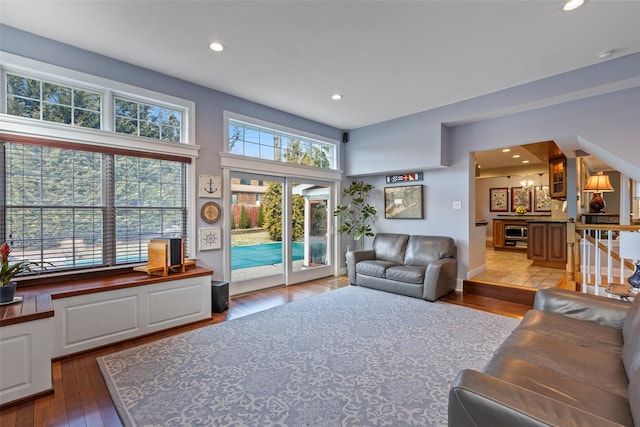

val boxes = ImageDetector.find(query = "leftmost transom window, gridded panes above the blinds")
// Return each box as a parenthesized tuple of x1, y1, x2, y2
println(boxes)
(6, 74, 102, 129)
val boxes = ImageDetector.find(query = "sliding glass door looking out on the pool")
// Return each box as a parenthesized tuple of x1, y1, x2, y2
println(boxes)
(230, 172, 333, 294)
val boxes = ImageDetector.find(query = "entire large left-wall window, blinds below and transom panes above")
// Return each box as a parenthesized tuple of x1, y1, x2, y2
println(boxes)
(0, 59, 197, 280)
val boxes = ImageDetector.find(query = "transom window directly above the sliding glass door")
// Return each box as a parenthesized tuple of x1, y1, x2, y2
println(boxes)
(228, 119, 336, 169)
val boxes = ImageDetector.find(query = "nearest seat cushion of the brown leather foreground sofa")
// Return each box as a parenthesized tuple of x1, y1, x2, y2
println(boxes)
(484, 355, 633, 426)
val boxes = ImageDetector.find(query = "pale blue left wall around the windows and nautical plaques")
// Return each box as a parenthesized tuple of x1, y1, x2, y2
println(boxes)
(0, 25, 342, 280)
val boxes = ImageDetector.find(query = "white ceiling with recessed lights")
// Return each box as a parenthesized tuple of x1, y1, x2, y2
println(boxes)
(0, 0, 640, 130)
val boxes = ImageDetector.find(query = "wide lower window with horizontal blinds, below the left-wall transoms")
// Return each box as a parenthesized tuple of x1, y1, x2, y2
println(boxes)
(0, 140, 188, 271)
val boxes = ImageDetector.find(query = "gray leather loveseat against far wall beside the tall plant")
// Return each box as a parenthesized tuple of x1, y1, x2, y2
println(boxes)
(346, 233, 458, 301)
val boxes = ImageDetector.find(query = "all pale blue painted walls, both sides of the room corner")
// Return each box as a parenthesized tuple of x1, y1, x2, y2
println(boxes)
(0, 26, 640, 278)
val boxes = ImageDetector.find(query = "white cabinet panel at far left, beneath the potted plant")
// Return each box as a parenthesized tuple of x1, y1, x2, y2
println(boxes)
(0, 318, 51, 404)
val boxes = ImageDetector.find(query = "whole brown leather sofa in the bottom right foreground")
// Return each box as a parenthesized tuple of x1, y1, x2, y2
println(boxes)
(449, 289, 640, 427)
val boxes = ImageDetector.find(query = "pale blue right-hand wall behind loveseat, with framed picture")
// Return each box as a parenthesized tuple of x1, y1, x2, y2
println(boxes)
(344, 54, 640, 279)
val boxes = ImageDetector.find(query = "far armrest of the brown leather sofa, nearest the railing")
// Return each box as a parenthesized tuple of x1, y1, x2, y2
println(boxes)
(533, 288, 631, 329)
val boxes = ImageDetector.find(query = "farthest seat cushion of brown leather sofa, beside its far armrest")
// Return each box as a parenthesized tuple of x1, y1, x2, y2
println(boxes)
(518, 310, 623, 357)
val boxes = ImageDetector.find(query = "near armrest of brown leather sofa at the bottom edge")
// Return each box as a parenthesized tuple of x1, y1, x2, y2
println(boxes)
(449, 369, 619, 427)
